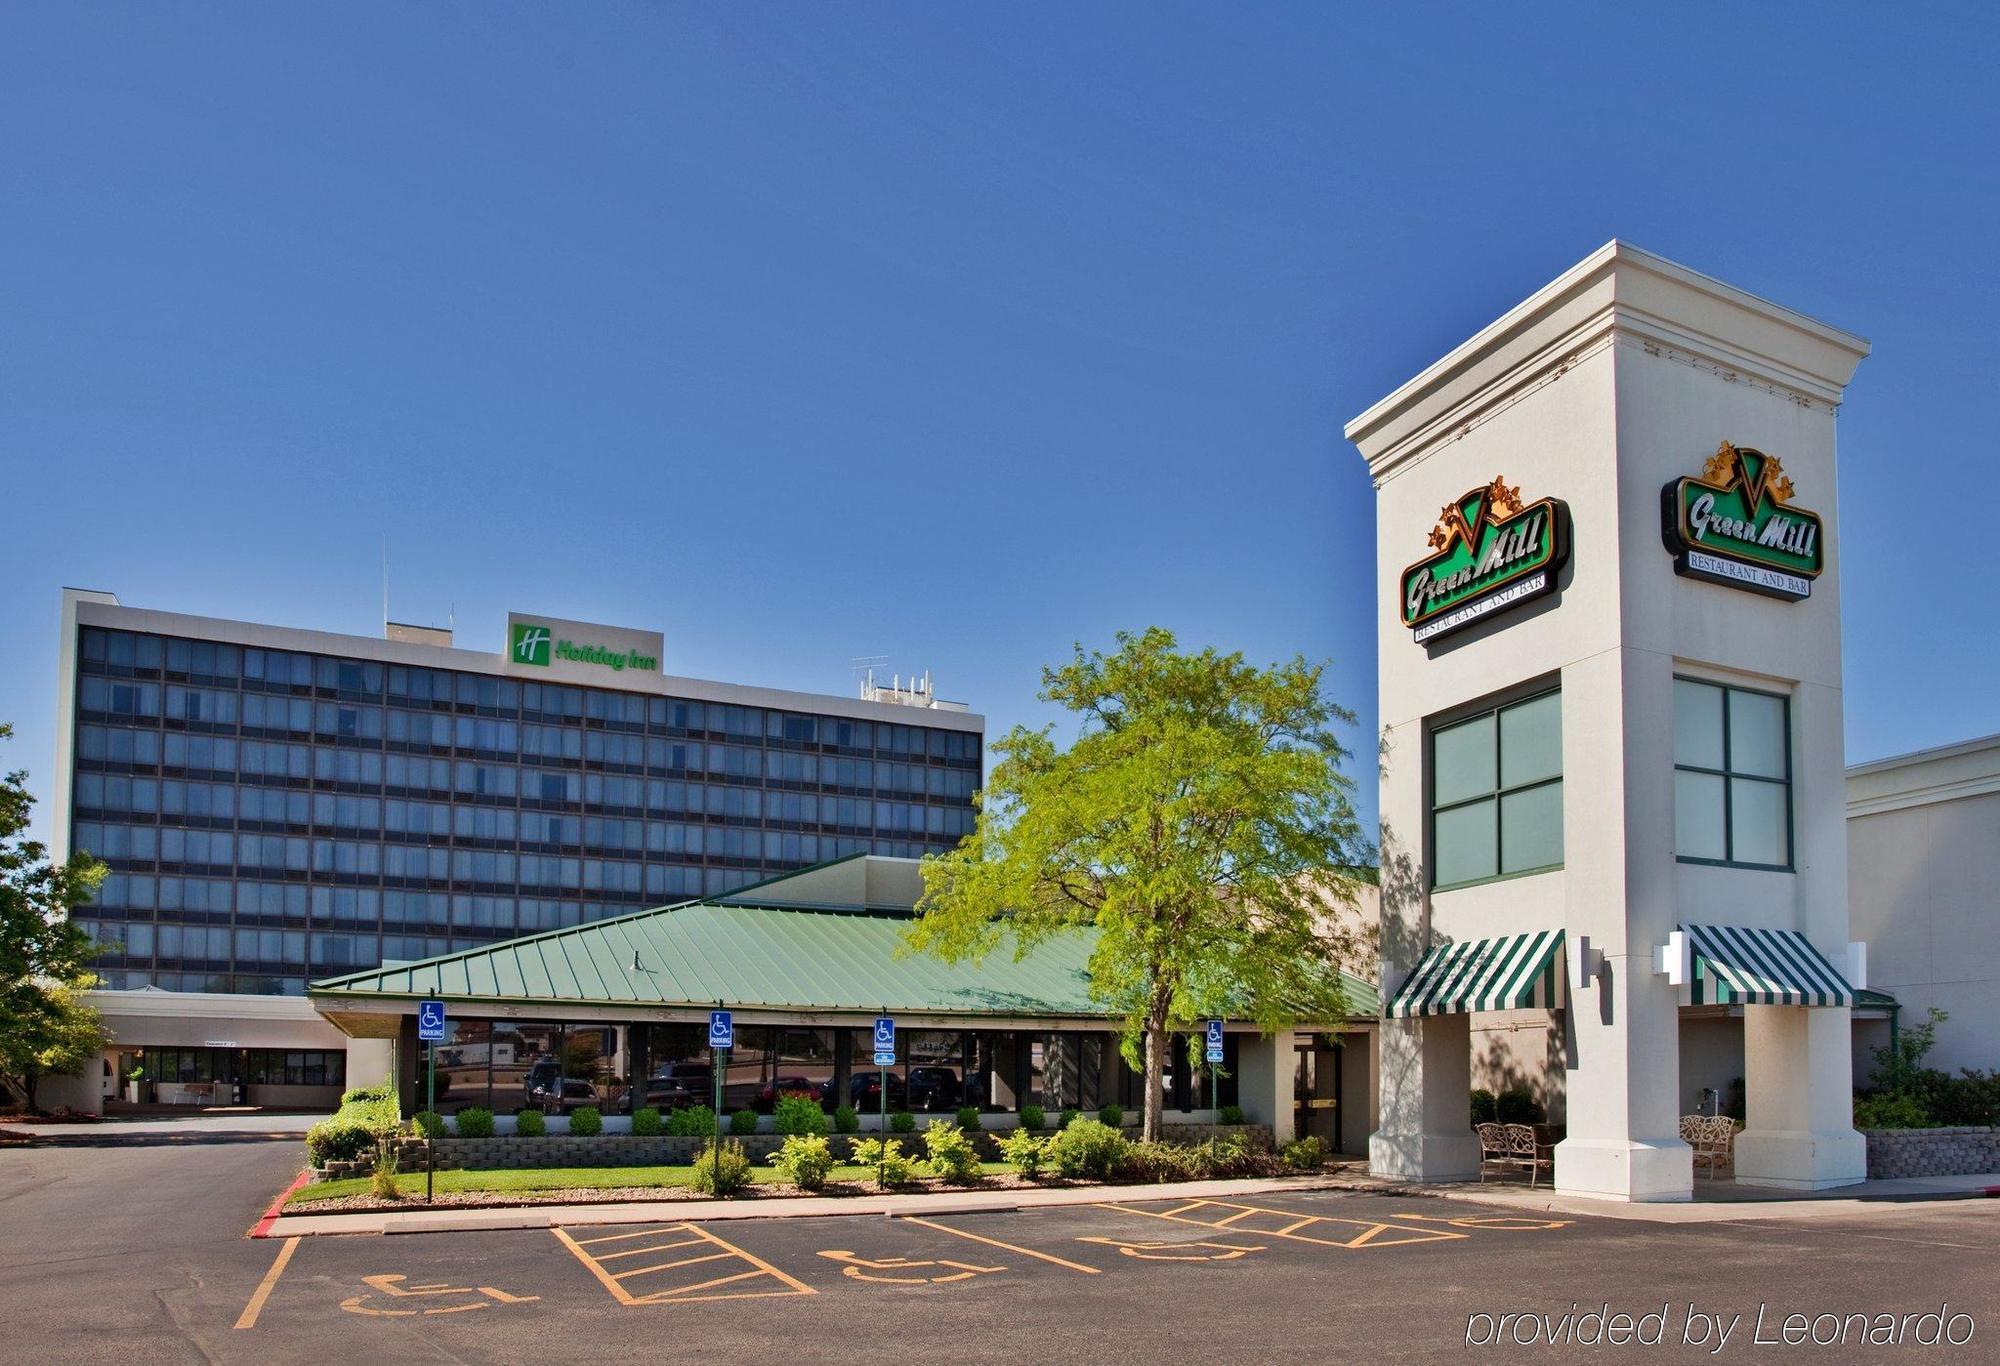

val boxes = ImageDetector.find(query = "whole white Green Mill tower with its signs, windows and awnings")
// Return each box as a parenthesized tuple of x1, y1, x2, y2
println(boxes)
(1346, 242, 1868, 1200)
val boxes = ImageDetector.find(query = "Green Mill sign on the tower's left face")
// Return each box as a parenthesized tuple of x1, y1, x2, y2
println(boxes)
(1398, 478, 1570, 644)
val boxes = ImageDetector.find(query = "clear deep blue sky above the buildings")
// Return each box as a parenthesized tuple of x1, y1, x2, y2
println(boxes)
(0, 2, 2000, 844)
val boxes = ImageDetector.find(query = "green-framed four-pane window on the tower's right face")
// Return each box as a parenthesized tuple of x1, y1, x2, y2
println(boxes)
(1674, 678, 1792, 868)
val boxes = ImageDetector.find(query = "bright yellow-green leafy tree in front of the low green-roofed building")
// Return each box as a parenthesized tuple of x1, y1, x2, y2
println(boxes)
(908, 626, 1368, 1140)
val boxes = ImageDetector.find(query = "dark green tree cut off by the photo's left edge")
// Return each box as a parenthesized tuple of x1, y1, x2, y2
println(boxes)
(0, 726, 106, 1110)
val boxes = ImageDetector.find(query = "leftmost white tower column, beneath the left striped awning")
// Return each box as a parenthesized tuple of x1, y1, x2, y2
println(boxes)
(1368, 1014, 1480, 1182)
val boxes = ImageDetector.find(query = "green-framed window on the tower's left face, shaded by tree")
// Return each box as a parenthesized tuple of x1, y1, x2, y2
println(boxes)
(1430, 692, 1562, 888)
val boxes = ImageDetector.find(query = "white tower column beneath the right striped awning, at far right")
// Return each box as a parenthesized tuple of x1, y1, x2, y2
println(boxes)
(1736, 1006, 1868, 1190)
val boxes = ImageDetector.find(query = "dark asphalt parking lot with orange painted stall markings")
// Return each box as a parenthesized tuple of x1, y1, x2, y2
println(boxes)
(0, 1142, 2000, 1362)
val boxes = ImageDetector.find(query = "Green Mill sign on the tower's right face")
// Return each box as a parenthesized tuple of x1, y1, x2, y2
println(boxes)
(1660, 442, 1826, 602)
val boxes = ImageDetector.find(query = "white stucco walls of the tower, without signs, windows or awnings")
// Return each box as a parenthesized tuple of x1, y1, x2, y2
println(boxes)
(1346, 242, 1868, 1200)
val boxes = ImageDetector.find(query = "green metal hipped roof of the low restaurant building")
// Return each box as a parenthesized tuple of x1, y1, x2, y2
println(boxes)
(310, 894, 1378, 1018)
